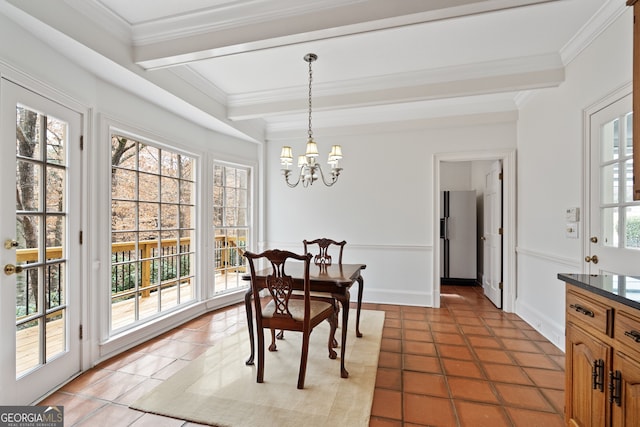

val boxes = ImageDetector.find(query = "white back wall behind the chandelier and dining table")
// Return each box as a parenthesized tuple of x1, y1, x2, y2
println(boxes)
(263, 119, 516, 306)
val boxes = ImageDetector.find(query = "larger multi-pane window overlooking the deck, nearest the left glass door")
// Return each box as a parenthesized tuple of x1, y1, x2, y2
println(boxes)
(111, 134, 196, 331)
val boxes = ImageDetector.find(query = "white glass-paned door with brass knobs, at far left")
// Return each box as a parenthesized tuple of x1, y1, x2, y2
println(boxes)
(0, 79, 82, 405)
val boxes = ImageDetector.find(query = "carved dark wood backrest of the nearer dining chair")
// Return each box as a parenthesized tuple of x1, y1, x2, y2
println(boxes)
(244, 249, 311, 322)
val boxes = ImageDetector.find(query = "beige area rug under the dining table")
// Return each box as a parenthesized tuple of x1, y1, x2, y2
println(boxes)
(131, 310, 384, 427)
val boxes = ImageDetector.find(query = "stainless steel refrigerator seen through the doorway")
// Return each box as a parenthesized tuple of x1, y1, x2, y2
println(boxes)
(440, 191, 478, 284)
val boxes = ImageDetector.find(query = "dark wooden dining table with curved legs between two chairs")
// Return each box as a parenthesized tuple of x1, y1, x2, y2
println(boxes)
(242, 262, 367, 378)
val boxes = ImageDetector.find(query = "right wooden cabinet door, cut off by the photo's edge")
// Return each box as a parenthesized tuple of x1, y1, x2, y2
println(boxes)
(612, 352, 640, 427)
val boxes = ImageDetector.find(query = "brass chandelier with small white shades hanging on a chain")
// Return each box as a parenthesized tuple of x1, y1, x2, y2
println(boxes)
(280, 53, 342, 188)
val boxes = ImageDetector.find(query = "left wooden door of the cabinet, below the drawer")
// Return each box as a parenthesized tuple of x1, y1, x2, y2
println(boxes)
(565, 323, 611, 427)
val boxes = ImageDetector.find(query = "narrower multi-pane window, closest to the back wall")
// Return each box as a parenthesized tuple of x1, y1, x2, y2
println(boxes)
(213, 164, 249, 294)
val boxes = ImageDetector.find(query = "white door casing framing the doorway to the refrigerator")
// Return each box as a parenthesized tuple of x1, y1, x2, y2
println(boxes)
(432, 149, 516, 312)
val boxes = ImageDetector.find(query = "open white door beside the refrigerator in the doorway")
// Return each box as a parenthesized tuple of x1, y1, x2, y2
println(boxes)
(482, 160, 502, 308)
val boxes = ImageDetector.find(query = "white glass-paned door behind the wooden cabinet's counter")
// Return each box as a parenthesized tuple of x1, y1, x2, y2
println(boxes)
(585, 94, 640, 275)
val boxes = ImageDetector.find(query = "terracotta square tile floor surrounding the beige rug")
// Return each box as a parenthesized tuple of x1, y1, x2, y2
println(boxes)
(41, 286, 564, 427)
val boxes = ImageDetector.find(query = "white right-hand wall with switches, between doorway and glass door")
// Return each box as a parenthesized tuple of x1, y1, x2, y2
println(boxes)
(517, 8, 633, 348)
